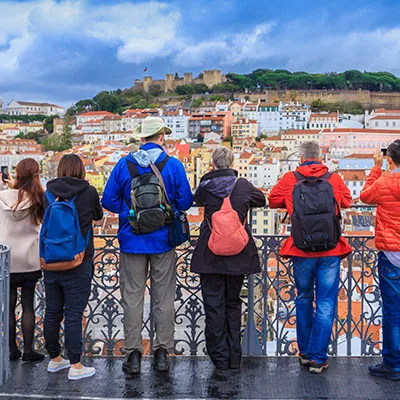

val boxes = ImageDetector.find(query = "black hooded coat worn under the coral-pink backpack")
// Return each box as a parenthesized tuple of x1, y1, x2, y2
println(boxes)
(191, 169, 265, 275)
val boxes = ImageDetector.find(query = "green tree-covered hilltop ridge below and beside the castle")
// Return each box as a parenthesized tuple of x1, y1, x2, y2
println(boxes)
(67, 69, 400, 115)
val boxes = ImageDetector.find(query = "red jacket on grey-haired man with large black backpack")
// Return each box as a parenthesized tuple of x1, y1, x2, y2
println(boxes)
(268, 163, 351, 258)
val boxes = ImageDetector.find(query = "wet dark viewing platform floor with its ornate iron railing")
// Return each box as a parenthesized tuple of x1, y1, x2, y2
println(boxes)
(5, 236, 400, 400)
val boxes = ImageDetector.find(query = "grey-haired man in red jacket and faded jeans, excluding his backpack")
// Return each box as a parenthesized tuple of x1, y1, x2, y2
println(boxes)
(268, 142, 351, 373)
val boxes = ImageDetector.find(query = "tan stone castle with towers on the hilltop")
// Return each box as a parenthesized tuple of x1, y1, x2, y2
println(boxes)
(134, 69, 226, 93)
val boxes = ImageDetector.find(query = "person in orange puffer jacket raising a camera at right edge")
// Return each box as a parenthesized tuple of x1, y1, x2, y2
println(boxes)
(360, 139, 400, 381)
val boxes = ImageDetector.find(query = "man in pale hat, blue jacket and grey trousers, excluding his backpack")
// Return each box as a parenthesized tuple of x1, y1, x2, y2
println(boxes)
(102, 117, 193, 374)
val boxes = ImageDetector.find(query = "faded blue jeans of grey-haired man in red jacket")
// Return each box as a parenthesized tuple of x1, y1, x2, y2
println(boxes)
(293, 257, 340, 363)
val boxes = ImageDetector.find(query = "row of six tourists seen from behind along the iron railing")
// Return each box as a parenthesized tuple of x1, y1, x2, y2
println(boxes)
(0, 117, 400, 380)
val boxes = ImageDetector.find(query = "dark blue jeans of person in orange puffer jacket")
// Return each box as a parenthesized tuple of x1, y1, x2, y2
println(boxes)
(378, 252, 400, 371)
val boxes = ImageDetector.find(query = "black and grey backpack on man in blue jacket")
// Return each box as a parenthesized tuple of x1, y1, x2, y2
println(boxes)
(127, 156, 172, 234)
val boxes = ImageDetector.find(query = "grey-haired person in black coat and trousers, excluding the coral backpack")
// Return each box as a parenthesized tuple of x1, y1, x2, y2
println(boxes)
(191, 147, 265, 370)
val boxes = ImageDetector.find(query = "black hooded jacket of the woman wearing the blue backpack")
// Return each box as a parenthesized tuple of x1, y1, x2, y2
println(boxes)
(44, 177, 103, 258)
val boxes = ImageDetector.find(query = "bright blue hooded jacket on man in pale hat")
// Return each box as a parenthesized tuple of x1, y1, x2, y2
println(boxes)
(102, 143, 193, 254)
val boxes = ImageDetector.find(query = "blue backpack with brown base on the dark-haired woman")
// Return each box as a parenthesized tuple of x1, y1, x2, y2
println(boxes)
(40, 190, 90, 271)
